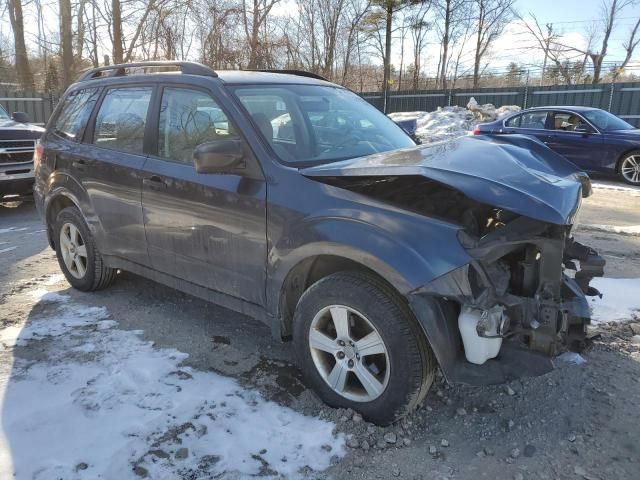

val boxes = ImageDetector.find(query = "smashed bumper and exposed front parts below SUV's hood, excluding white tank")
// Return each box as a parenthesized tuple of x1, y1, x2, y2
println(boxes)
(409, 217, 605, 384)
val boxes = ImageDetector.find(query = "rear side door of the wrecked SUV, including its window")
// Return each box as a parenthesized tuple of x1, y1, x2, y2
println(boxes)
(80, 85, 154, 265)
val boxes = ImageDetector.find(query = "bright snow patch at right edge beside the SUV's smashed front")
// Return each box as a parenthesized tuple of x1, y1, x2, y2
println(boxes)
(587, 278, 640, 324)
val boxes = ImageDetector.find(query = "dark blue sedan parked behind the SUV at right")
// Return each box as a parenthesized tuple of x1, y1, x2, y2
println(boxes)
(474, 107, 640, 185)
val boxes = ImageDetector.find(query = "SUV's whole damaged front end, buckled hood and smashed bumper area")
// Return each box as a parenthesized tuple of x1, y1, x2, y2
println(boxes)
(304, 137, 605, 384)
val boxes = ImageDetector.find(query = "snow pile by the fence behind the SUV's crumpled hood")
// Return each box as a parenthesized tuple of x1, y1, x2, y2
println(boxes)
(389, 98, 520, 143)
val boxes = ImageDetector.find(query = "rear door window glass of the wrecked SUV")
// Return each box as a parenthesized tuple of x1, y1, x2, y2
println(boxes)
(93, 87, 152, 153)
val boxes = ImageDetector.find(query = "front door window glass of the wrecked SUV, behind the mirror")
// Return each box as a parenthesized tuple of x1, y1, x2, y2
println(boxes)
(158, 88, 237, 164)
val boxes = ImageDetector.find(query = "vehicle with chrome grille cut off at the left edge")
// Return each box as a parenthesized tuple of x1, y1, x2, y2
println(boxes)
(0, 105, 44, 201)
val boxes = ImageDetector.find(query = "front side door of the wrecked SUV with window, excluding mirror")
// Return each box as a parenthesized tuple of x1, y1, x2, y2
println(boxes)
(142, 87, 267, 305)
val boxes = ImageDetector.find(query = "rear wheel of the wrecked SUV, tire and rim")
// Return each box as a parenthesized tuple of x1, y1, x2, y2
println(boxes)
(54, 207, 117, 292)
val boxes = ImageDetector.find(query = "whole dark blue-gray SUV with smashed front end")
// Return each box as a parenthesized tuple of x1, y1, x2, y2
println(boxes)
(35, 62, 604, 424)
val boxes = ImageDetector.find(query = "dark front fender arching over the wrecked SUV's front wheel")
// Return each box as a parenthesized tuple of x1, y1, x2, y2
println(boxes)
(267, 209, 471, 311)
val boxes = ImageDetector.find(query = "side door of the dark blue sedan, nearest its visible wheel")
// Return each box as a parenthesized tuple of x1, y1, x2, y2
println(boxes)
(546, 111, 607, 170)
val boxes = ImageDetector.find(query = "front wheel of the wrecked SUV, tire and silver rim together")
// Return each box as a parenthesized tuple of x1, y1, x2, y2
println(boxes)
(293, 272, 436, 425)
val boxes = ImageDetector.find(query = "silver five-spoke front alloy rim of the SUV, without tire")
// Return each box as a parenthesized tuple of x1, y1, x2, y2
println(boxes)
(309, 305, 390, 402)
